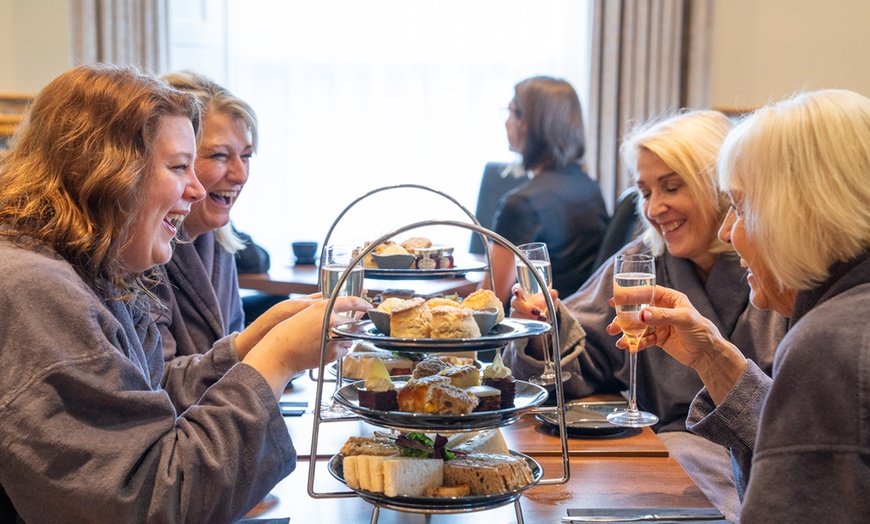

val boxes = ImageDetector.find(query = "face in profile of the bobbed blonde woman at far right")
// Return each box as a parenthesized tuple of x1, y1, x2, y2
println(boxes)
(719, 191, 797, 316)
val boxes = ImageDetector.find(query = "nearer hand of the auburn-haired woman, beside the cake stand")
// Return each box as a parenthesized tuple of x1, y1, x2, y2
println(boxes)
(242, 297, 371, 398)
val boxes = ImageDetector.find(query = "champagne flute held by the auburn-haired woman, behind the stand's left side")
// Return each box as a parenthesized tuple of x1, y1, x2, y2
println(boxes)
(319, 245, 364, 418)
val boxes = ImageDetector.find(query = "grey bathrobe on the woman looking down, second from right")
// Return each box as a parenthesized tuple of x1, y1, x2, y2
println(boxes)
(505, 240, 787, 521)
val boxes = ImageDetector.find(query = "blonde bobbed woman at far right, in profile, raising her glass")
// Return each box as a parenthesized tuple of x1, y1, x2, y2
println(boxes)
(632, 90, 870, 524)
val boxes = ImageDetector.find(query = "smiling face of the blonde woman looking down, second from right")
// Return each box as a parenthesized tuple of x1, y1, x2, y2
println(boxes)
(637, 148, 718, 271)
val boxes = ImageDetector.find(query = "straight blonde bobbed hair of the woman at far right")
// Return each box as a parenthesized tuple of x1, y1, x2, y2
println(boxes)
(719, 90, 870, 290)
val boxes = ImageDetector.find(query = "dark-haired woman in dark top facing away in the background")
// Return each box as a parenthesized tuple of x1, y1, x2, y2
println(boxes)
(485, 76, 608, 303)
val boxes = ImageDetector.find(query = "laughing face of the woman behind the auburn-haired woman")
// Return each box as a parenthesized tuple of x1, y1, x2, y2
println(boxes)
(184, 113, 254, 239)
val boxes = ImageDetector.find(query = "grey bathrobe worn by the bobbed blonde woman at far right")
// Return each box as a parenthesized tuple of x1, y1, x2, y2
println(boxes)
(688, 254, 870, 524)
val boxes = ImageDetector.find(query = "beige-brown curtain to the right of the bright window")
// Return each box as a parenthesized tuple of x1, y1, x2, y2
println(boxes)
(586, 0, 714, 210)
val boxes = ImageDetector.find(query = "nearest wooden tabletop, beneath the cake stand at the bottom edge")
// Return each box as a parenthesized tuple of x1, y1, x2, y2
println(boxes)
(245, 456, 711, 524)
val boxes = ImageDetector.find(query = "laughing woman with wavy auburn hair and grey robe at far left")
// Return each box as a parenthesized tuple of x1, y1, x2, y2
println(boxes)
(0, 66, 368, 522)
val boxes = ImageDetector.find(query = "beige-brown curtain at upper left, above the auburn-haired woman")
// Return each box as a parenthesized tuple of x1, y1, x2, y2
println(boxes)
(70, 0, 169, 74)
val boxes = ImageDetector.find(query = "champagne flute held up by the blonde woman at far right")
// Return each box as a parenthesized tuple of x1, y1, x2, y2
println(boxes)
(607, 255, 659, 428)
